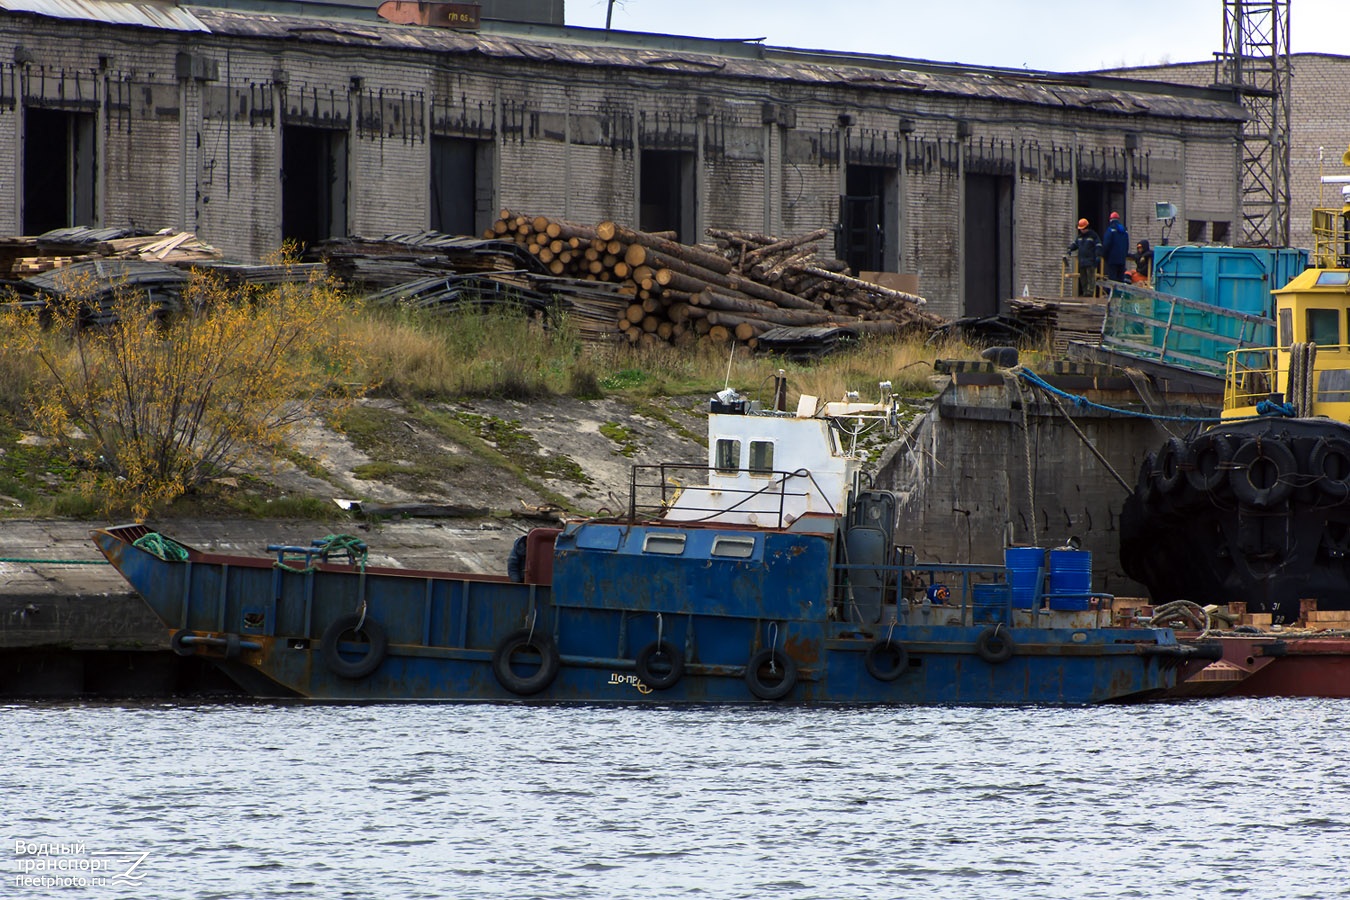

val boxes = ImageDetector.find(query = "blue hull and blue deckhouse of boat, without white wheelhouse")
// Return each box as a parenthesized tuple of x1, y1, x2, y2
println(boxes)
(93, 525, 1193, 704)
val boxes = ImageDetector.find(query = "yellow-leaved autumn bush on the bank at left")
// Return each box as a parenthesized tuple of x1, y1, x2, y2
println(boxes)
(3, 256, 365, 515)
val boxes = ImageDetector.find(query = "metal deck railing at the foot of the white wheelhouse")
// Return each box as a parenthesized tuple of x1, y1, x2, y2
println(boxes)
(628, 463, 819, 528)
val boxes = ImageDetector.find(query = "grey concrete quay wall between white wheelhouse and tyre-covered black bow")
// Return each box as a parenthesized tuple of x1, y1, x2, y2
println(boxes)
(876, 366, 1218, 596)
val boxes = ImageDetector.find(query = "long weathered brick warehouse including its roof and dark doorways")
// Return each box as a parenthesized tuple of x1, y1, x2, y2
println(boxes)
(0, 0, 1242, 316)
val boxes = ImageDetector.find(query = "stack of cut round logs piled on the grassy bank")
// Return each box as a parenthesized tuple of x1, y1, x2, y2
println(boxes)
(483, 209, 942, 347)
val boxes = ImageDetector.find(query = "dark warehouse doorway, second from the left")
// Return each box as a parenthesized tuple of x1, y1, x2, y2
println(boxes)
(281, 125, 347, 246)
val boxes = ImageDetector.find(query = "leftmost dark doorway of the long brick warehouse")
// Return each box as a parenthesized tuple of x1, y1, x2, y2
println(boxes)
(23, 108, 96, 235)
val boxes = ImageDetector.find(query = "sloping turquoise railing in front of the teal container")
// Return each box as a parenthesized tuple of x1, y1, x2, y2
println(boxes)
(1102, 282, 1274, 375)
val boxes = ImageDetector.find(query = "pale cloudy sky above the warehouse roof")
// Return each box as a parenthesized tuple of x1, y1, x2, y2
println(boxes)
(564, 0, 1350, 72)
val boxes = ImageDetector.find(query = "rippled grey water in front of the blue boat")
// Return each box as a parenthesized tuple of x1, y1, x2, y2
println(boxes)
(0, 700, 1350, 900)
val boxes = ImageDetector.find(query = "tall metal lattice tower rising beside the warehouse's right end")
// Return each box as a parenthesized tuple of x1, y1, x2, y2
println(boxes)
(1215, 0, 1292, 247)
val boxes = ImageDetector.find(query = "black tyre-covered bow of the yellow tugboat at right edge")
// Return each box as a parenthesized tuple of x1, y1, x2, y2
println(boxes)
(1121, 418, 1350, 623)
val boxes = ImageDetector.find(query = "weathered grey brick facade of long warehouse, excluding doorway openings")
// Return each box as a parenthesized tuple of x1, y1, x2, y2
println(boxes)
(0, 12, 1238, 316)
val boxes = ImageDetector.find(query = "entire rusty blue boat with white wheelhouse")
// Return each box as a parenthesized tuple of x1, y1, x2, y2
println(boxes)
(93, 385, 1212, 704)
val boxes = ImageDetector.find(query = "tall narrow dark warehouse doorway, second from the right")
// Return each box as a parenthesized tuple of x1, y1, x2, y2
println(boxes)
(964, 174, 1013, 316)
